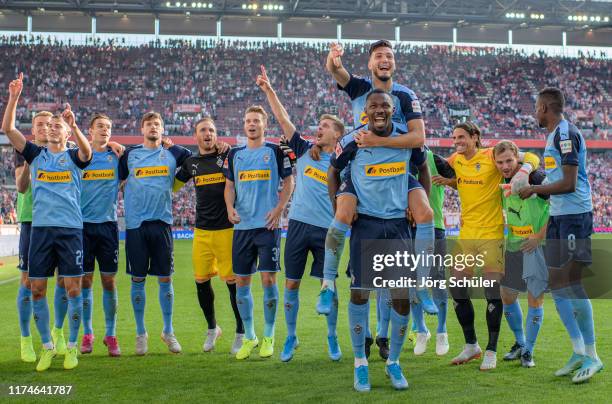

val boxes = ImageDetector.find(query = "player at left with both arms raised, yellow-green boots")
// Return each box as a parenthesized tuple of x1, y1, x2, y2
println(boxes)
(2, 73, 92, 371)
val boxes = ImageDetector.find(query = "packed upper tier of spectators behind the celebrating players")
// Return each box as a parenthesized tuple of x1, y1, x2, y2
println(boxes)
(0, 36, 612, 139)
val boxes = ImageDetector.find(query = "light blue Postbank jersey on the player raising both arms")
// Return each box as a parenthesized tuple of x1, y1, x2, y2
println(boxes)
(22, 141, 89, 229)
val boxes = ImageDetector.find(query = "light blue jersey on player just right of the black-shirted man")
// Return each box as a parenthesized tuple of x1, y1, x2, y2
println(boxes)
(224, 142, 291, 230)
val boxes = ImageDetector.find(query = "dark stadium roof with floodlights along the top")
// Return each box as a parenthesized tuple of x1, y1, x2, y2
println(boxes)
(0, 0, 612, 30)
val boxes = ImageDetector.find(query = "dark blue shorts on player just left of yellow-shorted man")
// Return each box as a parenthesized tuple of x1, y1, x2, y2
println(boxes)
(125, 220, 174, 278)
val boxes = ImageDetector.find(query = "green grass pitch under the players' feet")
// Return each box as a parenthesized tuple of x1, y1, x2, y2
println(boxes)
(0, 240, 612, 403)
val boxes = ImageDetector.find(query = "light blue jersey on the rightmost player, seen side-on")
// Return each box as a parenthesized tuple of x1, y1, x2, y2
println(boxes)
(544, 119, 593, 216)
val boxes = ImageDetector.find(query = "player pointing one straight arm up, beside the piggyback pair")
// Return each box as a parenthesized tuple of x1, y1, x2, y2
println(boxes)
(257, 66, 344, 362)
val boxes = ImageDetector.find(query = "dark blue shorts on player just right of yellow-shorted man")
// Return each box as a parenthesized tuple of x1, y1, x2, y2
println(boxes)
(232, 228, 281, 276)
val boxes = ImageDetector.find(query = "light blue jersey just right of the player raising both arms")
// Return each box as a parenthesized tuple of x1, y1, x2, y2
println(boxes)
(81, 149, 119, 223)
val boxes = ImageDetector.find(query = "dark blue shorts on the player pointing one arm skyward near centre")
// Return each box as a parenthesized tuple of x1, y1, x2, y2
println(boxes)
(285, 219, 327, 281)
